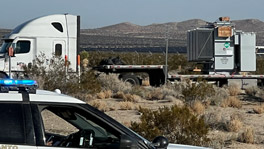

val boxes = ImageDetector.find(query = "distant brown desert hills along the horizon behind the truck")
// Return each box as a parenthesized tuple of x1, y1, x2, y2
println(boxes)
(0, 19, 264, 52)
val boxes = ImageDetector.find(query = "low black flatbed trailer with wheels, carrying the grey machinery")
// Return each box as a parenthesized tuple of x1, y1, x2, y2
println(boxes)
(94, 65, 264, 88)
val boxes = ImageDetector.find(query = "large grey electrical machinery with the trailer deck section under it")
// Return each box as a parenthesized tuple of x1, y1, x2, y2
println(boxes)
(179, 17, 263, 87)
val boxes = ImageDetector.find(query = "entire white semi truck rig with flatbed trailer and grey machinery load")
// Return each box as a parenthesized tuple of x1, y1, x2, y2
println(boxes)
(0, 14, 264, 87)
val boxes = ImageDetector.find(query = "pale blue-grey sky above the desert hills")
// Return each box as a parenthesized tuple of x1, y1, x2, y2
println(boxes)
(0, 0, 264, 29)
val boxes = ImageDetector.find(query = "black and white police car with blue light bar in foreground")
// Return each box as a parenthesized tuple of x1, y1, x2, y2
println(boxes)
(0, 79, 207, 149)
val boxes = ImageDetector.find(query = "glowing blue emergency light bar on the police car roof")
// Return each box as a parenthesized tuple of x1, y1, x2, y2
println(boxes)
(0, 79, 37, 86)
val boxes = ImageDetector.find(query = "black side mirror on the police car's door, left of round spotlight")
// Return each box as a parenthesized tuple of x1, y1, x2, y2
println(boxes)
(119, 135, 137, 149)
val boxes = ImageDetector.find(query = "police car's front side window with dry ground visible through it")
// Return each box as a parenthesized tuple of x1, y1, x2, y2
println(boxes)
(38, 105, 120, 148)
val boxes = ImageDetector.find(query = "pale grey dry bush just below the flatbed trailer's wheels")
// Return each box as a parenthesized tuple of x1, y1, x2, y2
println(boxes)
(97, 73, 132, 93)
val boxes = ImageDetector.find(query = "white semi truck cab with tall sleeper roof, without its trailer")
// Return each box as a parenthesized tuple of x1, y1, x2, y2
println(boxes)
(0, 14, 80, 72)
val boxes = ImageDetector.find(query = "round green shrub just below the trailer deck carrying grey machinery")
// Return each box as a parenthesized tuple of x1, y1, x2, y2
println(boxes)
(182, 80, 215, 102)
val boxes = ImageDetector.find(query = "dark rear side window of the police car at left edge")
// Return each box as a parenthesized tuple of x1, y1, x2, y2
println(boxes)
(0, 103, 26, 144)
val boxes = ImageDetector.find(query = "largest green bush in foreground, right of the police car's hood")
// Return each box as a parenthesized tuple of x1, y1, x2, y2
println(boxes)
(131, 105, 208, 145)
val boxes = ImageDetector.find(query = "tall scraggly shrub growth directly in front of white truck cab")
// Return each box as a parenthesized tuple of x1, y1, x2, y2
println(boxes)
(24, 54, 101, 94)
